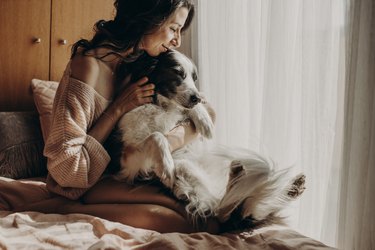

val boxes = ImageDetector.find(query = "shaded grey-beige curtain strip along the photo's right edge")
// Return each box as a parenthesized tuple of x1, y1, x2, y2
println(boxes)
(339, 0, 375, 249)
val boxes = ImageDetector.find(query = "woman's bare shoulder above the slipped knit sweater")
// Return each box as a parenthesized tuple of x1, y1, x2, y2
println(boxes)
(70, 54, 100, 88)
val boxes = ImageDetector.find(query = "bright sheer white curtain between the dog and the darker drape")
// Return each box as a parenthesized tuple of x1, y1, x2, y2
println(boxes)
(192, 0, 345, 246)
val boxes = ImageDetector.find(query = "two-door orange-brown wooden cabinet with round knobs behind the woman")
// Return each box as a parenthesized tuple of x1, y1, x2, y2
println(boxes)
(0, 0, 114, 111)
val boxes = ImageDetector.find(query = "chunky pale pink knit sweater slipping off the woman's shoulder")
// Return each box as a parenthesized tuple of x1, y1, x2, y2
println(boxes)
(44, 64, 110, 200)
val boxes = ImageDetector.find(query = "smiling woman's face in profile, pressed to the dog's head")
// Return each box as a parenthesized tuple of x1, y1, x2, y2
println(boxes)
(141, 7, 189, 56)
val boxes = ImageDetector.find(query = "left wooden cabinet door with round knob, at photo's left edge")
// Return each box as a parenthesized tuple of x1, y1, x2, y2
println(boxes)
(0, 0, 51, 111)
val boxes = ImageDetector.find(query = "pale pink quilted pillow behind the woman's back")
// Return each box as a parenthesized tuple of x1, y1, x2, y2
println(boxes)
(31, 79, 59, 141)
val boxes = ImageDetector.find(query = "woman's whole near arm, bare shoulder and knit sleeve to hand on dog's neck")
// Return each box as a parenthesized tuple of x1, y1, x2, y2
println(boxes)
(44, 57, 153, 199)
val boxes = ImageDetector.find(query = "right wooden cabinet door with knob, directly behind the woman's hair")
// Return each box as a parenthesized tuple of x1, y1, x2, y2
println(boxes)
(50, 0, 114, 81)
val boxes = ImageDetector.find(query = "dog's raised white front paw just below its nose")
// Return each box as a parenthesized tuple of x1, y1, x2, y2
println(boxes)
(188, 103, 214, 139)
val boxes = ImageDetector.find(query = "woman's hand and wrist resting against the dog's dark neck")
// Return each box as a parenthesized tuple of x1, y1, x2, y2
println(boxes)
(106, 77, 155, 121)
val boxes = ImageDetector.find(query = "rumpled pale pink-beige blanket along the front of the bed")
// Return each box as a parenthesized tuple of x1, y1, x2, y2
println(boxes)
(0, 212, 333, 250)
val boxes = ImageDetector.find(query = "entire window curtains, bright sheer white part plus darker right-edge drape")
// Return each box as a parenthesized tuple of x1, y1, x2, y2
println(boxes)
(190, 0, 375, 249)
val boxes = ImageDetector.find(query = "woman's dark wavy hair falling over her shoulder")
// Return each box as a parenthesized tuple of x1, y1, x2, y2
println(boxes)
(72, 0, 195, 62)
